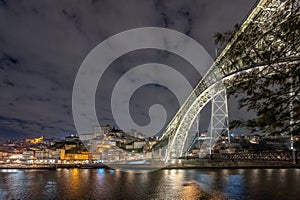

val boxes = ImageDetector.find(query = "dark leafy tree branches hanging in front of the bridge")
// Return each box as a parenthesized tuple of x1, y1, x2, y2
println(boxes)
(215, 0, 300, 135)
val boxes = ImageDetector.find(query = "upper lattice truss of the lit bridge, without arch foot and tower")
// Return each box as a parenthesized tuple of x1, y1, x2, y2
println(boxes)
(161, 0, 300, 139)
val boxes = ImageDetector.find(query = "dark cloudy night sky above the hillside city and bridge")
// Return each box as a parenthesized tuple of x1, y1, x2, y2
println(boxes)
(0, 0, 255, 139)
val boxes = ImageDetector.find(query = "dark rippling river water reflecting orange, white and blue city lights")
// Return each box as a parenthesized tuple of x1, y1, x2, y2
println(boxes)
(0, 169, 300, 200)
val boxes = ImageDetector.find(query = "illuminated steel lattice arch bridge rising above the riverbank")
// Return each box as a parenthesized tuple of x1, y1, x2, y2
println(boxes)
(154, 0, 300, 160)
